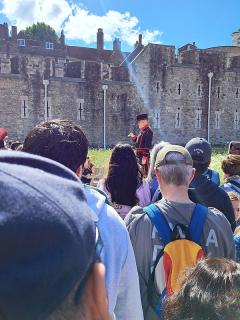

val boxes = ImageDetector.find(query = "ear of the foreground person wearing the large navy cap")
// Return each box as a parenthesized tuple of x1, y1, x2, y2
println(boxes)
(84, 262, 111, 320)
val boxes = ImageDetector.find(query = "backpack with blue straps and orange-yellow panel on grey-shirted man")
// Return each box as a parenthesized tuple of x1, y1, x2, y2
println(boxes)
(144, 204, 208, 319)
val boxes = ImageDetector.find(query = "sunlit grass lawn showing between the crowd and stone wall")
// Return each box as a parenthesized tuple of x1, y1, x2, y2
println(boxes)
(89, 148, 227, 182)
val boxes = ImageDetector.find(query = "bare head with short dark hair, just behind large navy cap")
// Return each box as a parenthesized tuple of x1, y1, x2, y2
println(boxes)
(23, 119, 88, 173)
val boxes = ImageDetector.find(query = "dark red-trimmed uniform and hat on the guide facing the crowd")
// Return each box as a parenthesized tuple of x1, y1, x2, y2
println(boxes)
(132, 114, 153, 174)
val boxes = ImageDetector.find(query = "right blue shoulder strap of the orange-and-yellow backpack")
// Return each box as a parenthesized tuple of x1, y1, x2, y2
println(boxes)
(188, 203, 208, 244)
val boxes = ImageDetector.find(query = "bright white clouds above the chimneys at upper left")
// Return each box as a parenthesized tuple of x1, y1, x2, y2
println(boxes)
(2, 0, 162, 45)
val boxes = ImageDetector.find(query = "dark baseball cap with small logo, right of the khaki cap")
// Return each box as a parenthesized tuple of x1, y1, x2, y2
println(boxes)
(185, 138, 212, 163)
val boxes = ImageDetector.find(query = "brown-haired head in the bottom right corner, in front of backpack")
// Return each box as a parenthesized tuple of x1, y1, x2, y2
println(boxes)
(164, 258, 240, 320)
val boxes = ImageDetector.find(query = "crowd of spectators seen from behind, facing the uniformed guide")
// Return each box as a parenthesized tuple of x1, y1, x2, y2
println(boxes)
(0, 119, 240, 320)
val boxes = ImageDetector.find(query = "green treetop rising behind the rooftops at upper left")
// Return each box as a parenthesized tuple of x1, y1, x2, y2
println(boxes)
(23, 22, 59, 43)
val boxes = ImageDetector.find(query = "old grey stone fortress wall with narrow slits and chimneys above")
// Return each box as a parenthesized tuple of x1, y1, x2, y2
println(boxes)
(0, 24, 240, 147)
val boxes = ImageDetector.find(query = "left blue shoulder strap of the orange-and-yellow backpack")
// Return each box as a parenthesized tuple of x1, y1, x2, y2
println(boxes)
(143, 204, 172, 246)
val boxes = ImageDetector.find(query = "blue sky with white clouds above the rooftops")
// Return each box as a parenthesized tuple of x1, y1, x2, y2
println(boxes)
(0, 0, 240, 50)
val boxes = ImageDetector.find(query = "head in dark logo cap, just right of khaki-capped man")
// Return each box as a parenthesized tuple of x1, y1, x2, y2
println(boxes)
(185, 138, 212, 176)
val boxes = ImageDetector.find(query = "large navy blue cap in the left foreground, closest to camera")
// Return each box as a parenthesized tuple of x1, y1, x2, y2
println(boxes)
(0, 151, 96, 320)
